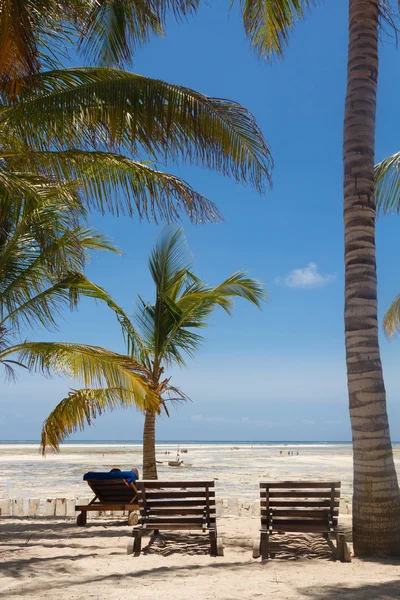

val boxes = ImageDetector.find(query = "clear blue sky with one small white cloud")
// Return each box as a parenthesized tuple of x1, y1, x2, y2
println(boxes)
(0, 0, 400, 441)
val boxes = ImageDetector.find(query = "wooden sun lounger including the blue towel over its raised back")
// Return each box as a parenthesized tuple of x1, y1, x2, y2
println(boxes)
(75, 471, 139, 525)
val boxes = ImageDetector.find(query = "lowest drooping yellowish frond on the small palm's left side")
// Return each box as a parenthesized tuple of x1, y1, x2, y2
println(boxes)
(41, 388, 158, 454)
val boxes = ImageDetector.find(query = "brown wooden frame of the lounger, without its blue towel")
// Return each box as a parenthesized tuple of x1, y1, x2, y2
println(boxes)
(75, 479, 139, 525)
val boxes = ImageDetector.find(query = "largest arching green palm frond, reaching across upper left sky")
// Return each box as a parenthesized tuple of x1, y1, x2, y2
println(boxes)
(6, 68, 272, 192)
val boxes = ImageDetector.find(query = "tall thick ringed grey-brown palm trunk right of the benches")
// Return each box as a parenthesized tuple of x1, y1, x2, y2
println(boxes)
(343, 0, 400, 556)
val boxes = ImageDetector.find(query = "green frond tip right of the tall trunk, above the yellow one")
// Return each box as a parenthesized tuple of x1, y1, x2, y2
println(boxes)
(374, 152, 400, 214)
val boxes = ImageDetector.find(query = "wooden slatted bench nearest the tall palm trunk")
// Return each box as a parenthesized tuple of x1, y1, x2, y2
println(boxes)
(253, 481, 350, 561)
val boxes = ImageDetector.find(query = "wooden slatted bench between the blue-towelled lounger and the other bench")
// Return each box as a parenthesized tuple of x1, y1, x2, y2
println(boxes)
(127, 481, 223, 556)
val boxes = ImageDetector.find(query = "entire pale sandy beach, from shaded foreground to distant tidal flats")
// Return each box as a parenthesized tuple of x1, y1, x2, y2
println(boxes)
(0, 443, 400, 600)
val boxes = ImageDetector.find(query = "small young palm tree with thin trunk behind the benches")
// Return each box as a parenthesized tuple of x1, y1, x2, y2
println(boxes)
(42, 228, 264, 479)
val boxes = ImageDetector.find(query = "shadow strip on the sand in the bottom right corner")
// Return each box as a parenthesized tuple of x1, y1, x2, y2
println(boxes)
(298, 579, 400, 600)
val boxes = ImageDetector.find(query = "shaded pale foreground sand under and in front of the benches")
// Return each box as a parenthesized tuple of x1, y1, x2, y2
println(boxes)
(0, 517, 400, 600)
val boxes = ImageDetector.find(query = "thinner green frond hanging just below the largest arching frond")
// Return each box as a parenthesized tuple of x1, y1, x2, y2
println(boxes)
(8, 150, 222, 223)
